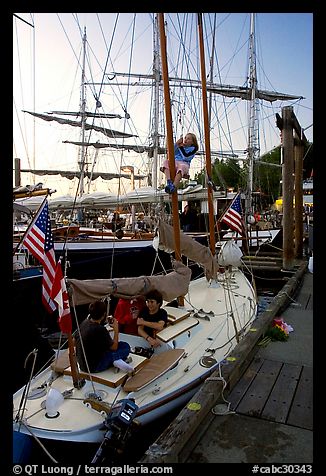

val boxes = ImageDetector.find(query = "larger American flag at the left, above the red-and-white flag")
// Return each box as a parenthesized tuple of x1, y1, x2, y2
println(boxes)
(22, 200, 56, 312)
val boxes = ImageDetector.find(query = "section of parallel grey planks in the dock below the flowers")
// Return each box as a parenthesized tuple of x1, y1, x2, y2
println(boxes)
(228, 358, 313, 430)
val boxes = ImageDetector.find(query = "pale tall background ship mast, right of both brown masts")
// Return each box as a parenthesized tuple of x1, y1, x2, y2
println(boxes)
(246, 13, 259, 215)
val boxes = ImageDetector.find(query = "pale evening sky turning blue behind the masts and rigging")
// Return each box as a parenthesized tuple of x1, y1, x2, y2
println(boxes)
(13, 12, 313, 196)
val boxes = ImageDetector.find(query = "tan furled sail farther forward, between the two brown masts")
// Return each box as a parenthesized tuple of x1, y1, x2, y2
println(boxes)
(158, 220, 218, 279)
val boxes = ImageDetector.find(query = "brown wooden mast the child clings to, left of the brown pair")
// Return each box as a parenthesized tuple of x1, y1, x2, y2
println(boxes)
(158, 13, 181, 261)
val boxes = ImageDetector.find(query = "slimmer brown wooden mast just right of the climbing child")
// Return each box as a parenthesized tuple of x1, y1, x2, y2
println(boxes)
(197, 13, 215, 256)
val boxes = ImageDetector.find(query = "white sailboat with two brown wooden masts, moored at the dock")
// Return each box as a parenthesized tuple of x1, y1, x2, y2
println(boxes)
(13, 13, 257, 454)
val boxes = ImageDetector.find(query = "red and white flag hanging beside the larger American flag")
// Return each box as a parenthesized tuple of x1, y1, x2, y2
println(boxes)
(51, 259, 72, 334)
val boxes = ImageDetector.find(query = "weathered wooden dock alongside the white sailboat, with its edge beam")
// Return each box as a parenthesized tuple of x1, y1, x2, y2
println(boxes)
(140, 262, 313, 464)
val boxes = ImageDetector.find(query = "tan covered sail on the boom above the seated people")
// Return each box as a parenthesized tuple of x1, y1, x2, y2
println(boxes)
(67, 261, 191, 306)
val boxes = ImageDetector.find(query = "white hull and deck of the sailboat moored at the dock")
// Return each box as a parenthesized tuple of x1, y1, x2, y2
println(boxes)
(13, 269, 257, 443)
